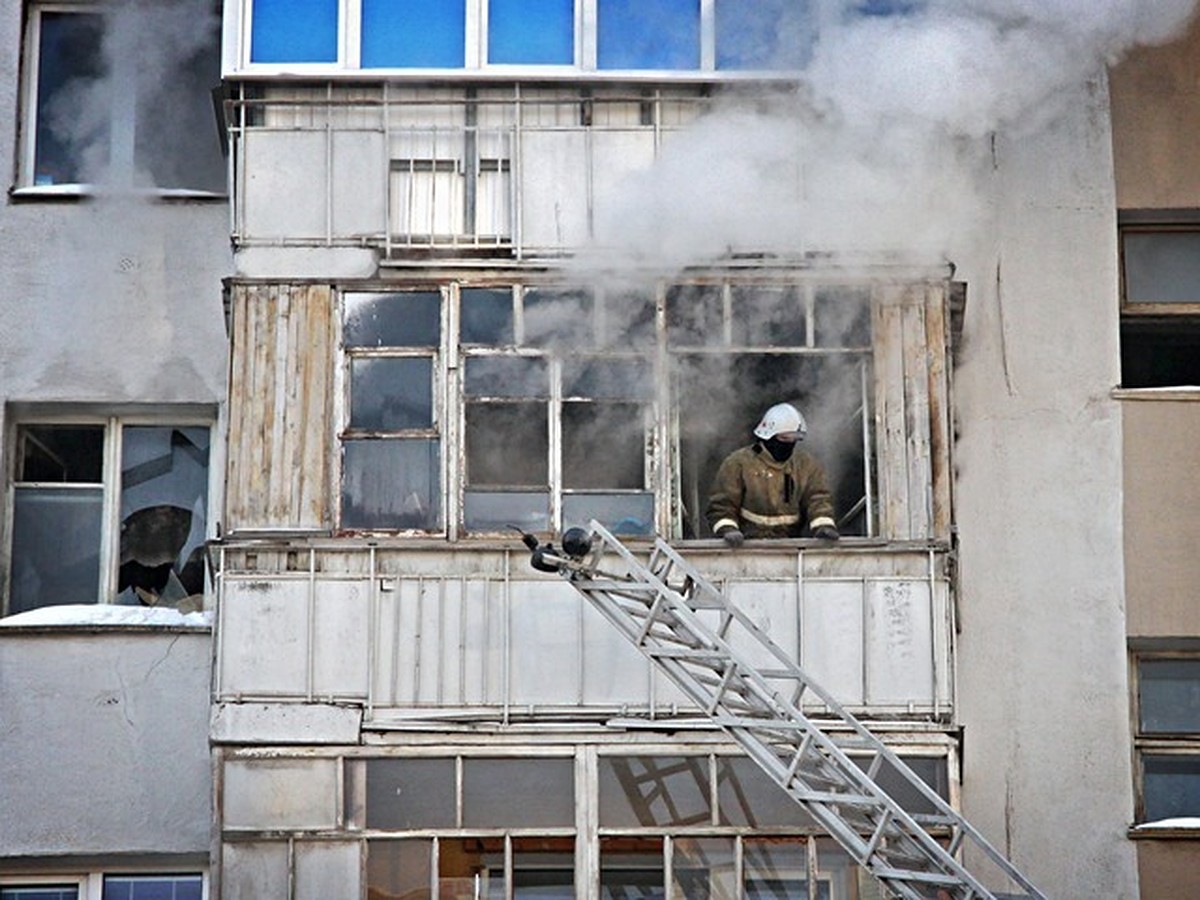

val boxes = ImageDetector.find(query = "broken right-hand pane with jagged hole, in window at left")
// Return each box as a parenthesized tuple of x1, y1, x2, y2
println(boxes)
(116, 426, 210, 611)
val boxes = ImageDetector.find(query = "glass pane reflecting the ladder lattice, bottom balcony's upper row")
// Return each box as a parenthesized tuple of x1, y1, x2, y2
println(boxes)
(600, 756, 712, 828)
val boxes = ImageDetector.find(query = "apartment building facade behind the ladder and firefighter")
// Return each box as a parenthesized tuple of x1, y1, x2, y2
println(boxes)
(0, 0, 1200, 900)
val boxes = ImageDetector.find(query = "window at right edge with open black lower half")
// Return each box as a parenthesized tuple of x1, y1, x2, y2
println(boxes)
(1121, 220, 1200, 388)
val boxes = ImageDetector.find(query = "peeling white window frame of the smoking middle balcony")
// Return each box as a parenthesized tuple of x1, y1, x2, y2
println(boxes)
(335, 274, 881, 541)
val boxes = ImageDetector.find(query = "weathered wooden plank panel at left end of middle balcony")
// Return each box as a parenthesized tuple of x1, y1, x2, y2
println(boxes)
(226, 284, 335, 533)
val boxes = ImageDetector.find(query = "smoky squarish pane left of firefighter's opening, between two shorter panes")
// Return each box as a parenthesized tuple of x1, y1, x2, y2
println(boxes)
(562, 402, 646, 491)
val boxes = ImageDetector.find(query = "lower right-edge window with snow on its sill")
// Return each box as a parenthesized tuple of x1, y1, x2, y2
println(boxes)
(1134, 653, 1200, 822)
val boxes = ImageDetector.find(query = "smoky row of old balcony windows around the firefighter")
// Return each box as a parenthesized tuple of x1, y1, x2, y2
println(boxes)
(341, 280, 876, 538)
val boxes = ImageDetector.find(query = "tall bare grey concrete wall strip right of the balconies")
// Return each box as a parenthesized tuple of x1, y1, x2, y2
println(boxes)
(955, 84, 1138, 898)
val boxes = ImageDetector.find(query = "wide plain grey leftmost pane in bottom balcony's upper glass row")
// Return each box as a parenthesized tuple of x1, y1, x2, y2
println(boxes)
(366, 760, 457, 830)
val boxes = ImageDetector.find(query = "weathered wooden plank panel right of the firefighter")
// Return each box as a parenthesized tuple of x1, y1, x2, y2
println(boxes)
(874, 284, 950, 540)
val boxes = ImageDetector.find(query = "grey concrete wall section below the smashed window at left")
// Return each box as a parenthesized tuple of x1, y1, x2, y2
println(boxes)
(0, 626, 212, 854)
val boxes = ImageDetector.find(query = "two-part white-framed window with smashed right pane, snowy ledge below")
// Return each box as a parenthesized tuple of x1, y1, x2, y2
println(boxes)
(7, 418, 211, 614)
